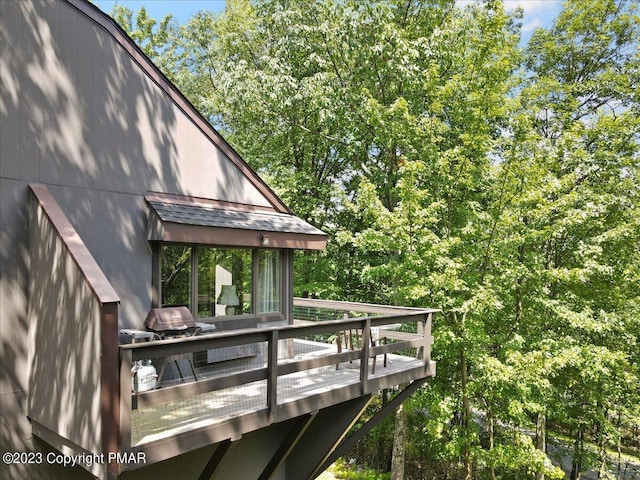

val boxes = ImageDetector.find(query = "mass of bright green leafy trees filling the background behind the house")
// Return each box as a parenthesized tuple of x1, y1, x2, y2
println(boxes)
(112, 0, 640, 478)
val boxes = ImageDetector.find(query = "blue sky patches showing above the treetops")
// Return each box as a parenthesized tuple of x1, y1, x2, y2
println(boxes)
(93, 0, 562, 43)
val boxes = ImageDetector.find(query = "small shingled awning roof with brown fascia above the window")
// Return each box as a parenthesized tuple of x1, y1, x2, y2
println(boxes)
(145, 194, 328, 250)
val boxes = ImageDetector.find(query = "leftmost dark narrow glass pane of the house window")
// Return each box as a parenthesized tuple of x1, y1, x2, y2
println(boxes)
(160, 245, 191, 306)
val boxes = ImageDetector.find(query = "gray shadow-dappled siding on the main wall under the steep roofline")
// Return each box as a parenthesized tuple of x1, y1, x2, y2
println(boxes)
(0, 0, 281, 479)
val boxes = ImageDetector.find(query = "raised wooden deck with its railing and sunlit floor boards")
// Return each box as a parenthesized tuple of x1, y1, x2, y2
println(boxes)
(120, 299, 435, 462)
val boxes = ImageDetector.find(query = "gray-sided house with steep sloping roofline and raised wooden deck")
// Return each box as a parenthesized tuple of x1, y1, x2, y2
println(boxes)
(0, 0, 435, 480)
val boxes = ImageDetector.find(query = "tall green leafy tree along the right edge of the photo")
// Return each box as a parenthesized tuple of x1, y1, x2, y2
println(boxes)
(515, 0, 640, 478)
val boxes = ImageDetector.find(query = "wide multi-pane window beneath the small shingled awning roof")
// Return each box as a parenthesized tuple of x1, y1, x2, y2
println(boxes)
(160, 244, 282, 318)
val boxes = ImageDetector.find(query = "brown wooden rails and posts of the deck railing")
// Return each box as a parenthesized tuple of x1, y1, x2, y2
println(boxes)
(120, 299, 436, 460)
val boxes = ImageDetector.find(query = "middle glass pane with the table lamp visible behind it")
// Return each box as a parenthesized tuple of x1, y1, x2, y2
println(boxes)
(198, 247, 253, 317)
